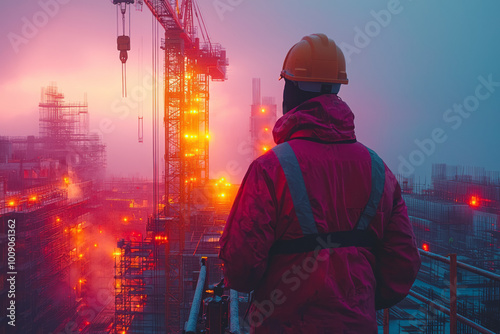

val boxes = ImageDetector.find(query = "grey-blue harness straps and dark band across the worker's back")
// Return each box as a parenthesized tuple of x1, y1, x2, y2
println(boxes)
(271, 142, 385, 254)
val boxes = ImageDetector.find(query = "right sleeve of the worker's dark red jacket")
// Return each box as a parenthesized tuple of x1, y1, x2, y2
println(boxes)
(375, 173, 420, 310)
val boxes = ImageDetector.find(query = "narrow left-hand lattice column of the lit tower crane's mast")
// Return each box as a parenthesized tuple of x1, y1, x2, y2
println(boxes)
(164, 31, 186, 333)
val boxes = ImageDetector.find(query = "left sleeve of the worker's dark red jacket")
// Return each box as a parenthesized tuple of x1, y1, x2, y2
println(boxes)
(219, 160, 276, 292)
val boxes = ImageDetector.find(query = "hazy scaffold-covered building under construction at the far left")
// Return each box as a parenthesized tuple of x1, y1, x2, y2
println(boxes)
(0, 85, 105, 333)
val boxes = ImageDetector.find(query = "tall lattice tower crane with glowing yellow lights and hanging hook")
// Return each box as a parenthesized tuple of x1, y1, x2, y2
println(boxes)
(113, 0, 228, 333)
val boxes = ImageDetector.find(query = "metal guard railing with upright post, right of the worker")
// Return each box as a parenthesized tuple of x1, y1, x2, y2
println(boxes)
(383, 249, 500, 334)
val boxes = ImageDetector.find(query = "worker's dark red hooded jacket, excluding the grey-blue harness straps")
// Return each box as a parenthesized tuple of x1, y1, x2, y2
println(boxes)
(219, 95, 420, 334)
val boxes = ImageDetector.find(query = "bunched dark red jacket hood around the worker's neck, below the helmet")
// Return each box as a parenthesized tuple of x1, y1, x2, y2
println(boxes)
(273, 94, 356, 144)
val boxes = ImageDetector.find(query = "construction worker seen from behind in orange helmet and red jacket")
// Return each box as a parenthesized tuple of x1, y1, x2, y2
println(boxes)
(219, 34, 420, 334)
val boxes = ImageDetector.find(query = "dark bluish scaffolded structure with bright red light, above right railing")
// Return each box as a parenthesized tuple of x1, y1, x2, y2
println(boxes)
(402, 164, 500, 270)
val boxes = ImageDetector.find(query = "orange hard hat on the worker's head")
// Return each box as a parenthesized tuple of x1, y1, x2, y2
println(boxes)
(281, 34, 349, 85)
